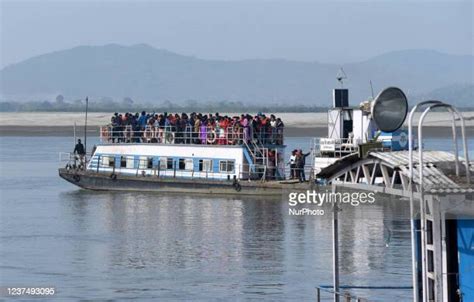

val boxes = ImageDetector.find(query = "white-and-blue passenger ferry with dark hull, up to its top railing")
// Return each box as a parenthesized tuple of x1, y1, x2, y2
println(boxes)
(59, 117, 316, 195)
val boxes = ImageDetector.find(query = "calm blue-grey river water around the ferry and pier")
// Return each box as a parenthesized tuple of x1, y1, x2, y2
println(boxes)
(0, 137, 474, 301)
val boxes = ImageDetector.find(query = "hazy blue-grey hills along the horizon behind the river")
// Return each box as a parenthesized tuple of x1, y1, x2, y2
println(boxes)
(0, 44, 474, 106)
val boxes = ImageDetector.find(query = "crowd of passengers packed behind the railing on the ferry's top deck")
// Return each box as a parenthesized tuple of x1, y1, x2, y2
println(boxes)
(101, 111, 284, 145)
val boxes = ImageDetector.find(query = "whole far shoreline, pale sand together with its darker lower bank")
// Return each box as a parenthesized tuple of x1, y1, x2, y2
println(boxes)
(0, 112, 474, 138)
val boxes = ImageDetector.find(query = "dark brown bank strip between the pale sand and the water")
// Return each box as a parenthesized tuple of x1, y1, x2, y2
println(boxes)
(0, 125, 474, 138)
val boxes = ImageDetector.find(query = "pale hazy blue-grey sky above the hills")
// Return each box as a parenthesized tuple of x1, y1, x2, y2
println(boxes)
(0, 0, 474, 67)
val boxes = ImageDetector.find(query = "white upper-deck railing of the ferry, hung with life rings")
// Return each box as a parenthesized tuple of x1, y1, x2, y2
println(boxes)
(100, 125, 283, 145)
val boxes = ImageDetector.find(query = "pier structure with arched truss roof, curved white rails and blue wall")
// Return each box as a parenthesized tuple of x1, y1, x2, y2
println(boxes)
(316, 101, 474, 302)
